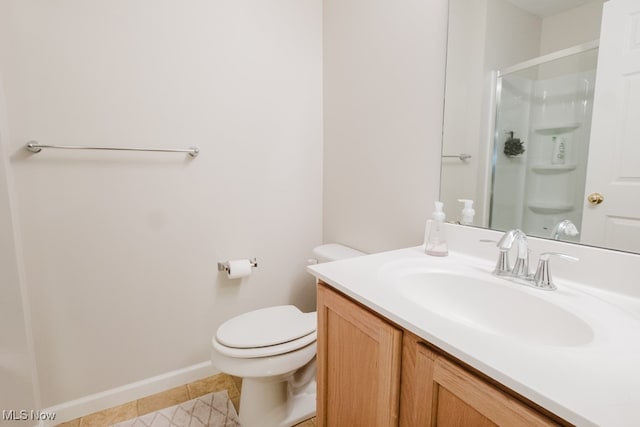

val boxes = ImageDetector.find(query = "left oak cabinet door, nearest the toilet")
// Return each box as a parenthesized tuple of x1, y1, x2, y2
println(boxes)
(317, 284, 402, 427)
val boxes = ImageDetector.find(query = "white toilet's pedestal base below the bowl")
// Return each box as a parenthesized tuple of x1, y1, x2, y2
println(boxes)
(238, 374, 316, 427)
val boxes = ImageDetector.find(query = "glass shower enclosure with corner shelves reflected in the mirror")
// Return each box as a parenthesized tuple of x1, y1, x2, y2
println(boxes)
(489, 46, 597, 241)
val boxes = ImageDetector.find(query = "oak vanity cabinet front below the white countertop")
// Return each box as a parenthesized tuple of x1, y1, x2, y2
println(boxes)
(317, 283, 571, 427)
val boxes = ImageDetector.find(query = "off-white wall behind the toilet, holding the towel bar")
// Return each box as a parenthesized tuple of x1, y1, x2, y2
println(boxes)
(0, 0, 322, 406)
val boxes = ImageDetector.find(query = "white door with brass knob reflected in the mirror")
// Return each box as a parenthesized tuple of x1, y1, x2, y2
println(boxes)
(580, 0, 640, 252)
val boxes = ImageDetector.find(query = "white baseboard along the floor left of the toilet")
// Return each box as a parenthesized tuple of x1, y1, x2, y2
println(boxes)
(38, 361, 219, 427)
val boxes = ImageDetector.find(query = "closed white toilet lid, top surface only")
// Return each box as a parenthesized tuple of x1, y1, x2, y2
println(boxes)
(216, 305, 316, 348)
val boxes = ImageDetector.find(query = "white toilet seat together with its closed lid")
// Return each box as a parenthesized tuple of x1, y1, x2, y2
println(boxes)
(212, 305, 317, 358)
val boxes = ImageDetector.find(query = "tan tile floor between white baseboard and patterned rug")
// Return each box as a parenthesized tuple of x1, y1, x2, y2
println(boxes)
(57, 374, 316, 427)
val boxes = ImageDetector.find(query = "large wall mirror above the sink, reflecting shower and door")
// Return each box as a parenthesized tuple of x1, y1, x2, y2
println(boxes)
(440, 0, 640, 253)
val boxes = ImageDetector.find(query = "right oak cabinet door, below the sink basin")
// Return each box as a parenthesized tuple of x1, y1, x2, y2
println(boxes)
(414, 344, 558, 427)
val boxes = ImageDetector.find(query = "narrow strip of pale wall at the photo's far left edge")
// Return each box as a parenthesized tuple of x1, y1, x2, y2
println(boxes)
(0, 78, 38, 426)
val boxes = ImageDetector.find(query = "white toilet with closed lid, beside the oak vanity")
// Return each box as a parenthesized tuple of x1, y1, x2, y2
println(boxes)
(211, 244, 364, 427)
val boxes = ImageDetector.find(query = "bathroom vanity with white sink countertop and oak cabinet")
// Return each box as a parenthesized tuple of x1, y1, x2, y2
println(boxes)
(309, 226, 640, 426)
